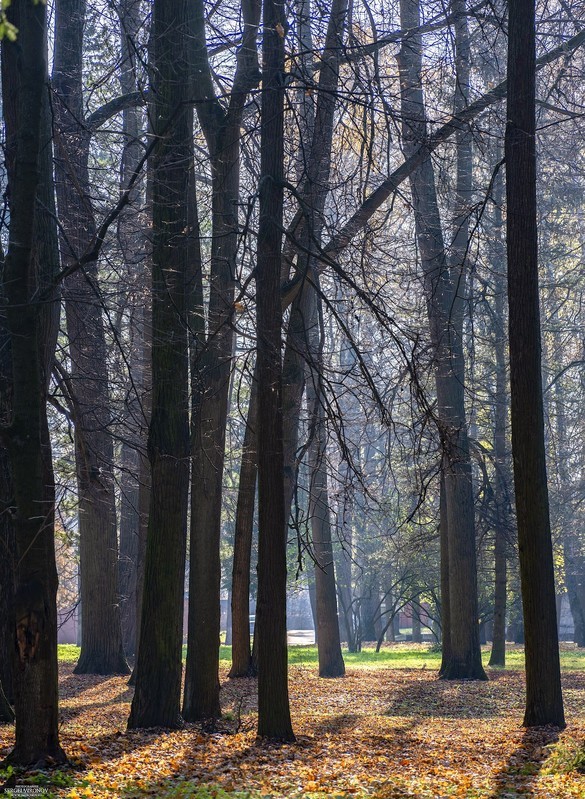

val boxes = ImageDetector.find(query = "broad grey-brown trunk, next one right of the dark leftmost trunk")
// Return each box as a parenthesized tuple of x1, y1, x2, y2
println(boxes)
(53, 0, 129, 674)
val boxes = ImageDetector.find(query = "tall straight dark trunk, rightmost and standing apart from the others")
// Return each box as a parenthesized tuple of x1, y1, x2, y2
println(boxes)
(505, 0, 565, 727)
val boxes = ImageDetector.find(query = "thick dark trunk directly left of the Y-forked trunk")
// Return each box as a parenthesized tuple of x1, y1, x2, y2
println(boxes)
(128, 0, 193, 728)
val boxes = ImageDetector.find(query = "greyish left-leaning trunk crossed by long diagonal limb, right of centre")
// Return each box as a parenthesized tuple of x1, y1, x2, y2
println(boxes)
(398, 0, 487, 680)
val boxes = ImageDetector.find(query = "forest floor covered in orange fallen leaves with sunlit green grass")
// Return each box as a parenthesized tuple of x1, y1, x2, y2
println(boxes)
(0, 644, 585, 799)
